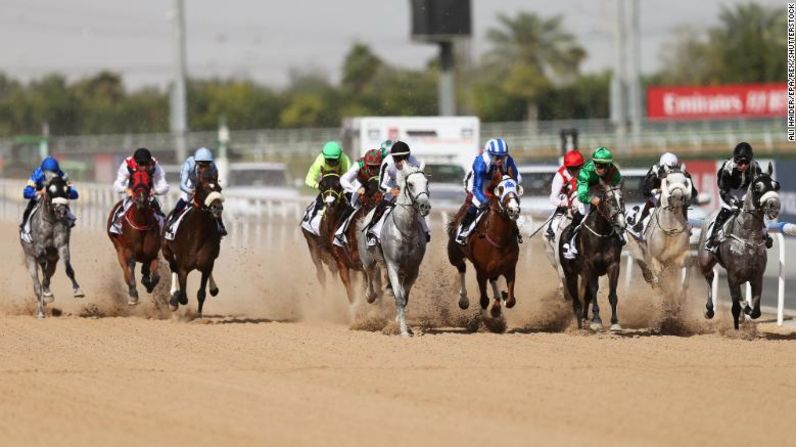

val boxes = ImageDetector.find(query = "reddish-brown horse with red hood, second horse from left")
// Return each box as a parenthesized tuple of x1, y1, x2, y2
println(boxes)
(107, 171, 160, 306)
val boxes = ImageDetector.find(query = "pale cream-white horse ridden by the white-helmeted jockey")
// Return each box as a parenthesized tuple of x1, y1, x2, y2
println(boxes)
(627, 169, 692, 313)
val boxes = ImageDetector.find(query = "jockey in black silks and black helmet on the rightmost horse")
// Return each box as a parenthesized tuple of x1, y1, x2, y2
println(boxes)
(705, 142, 774, 254)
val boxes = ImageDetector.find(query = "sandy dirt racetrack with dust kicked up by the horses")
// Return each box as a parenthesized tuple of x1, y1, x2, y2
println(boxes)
(0, 224, 796, 446)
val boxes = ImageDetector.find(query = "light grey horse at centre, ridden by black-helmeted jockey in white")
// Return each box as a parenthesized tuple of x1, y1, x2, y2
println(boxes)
(357, 164, 431, 337)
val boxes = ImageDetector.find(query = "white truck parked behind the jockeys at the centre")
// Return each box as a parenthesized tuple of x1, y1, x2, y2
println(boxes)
(343, 116, 481, 204)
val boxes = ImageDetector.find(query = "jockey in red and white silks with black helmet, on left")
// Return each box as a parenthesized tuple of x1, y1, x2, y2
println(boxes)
(109, 147, 169, 234)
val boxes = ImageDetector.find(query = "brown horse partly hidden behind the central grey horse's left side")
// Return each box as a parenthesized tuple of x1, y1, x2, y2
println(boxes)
(332, 177, 382, 303)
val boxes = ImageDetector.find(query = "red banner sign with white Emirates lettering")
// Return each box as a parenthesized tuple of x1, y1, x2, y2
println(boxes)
(647, 83, 788, 120)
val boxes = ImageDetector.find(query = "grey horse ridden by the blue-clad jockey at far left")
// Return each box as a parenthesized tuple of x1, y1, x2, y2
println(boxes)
(21, 176, 85, 318)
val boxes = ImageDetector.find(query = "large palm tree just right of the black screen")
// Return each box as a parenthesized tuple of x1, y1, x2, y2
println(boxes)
(486, 12, 586, 121)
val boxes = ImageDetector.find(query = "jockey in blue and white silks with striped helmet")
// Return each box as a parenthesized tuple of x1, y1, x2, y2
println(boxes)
(456, 138, 522, 245)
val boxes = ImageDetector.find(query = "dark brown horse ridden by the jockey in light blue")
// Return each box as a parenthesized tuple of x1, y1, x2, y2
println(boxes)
(163, 167, 224, 318)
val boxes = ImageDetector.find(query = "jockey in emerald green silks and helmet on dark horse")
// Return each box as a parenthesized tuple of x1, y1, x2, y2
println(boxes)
(563, 146, 625, 259)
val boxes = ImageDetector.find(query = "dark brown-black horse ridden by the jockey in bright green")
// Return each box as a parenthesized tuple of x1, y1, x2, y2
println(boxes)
(559, 184, 626, 330)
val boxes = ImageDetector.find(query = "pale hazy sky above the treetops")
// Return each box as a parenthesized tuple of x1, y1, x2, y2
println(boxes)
(0, 0, 785, 89)
